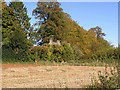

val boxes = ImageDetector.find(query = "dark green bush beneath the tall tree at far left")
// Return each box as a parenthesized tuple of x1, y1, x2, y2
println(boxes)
(2, 46, 29, 62)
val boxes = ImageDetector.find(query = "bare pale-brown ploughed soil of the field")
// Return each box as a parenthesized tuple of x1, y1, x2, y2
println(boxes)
(2, 64, 113, 88)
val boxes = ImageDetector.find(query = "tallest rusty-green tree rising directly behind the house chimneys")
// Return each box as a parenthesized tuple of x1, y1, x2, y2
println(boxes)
(33, 2, 64, 42)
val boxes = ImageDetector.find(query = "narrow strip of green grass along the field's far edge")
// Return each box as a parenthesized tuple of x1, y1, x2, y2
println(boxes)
(2, 59, 118, 66)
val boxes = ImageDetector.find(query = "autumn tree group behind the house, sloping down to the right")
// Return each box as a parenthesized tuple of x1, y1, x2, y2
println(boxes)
(33, 2, 113, 55)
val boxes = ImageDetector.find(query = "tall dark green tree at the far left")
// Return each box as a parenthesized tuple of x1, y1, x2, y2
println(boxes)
(2, 2, 31, 56)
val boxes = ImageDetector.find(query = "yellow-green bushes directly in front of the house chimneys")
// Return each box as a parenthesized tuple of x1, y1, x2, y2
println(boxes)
(28, 42, 74, 62)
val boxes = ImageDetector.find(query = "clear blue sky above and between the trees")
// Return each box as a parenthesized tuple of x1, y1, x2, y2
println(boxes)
(6, 2, 118, 47)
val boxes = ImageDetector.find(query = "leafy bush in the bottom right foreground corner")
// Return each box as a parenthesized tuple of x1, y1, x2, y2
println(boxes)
(89, 66, 120, 90)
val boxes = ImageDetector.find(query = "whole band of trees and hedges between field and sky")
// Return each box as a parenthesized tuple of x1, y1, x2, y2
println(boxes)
(2, 2, 119, 62)
